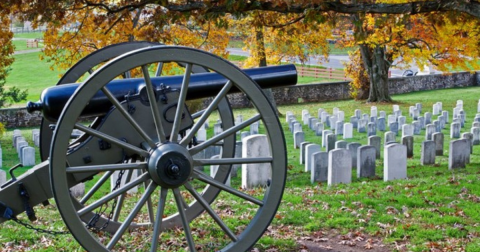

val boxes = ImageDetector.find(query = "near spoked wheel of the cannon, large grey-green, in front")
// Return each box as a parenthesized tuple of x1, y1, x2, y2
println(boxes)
(50, 46, 286, 251)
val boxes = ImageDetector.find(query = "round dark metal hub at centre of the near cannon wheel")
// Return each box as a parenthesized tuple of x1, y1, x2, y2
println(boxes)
(148, 143, 193, 188)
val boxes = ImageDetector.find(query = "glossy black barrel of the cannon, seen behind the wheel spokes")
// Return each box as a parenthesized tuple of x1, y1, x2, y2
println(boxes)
(27, 65, 297, 121)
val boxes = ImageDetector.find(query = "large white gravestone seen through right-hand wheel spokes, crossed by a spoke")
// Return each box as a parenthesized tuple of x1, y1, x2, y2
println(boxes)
(242, 135, 272, 189)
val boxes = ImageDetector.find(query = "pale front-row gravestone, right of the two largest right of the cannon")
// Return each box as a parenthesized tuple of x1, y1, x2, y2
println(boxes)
(383, 143, 407, 181)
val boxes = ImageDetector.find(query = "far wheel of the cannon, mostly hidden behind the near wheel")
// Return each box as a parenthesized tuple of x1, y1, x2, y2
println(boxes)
(40, 41, 235, 233)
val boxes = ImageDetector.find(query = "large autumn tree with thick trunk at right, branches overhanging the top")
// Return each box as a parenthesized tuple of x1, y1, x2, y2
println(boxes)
(6, 0, 480, 101)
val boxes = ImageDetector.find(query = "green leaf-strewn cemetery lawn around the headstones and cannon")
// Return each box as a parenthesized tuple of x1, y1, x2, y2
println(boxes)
(0, 87, 480, 251)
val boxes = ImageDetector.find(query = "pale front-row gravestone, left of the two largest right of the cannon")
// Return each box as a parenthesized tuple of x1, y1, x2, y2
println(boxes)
(328, 149, 352, 186)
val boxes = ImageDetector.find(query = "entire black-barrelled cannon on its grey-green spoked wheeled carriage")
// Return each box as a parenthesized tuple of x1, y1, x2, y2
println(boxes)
(0, 42, 297, 251)
